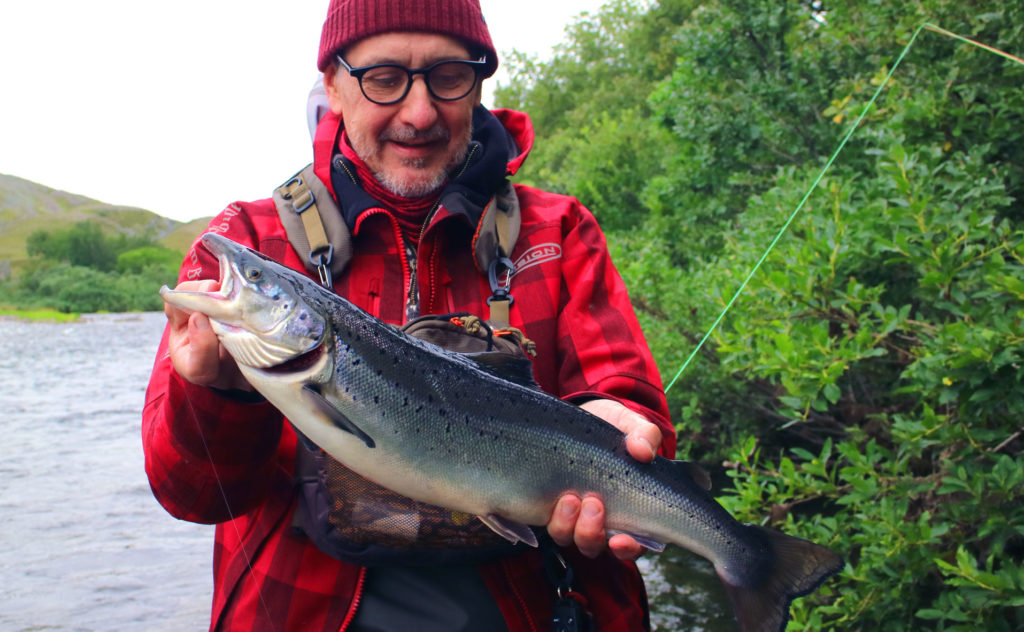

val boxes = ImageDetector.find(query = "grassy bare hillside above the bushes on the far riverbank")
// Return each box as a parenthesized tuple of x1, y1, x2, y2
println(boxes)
(0, 173, 209, 268)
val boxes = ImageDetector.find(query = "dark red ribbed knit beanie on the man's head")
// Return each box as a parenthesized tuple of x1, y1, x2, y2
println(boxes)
(316, 0, 498, 77)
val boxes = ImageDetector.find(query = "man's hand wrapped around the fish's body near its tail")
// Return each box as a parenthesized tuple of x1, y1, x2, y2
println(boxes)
(548, 399, 662, 559)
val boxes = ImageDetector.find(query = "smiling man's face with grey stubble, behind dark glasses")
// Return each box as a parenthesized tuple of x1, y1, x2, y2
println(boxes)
(324, 33, 480, 198)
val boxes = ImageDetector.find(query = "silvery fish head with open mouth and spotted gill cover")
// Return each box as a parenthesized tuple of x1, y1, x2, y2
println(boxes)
(160, 233, 327, 370)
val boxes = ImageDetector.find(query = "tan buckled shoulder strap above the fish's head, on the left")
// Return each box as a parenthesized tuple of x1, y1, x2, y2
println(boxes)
(273, 164, 352, 289)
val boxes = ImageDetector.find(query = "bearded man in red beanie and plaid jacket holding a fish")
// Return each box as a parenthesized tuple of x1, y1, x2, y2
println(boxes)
(142, 0, 675, 631)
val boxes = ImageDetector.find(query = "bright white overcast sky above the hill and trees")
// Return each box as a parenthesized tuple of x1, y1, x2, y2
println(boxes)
(0, 0, 603, 220)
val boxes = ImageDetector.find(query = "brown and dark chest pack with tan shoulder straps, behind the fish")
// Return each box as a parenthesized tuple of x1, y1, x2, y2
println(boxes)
(273, 165, 535, 566)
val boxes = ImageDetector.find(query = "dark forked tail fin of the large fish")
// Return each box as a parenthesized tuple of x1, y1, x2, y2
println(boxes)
(723, 525, 843, 632)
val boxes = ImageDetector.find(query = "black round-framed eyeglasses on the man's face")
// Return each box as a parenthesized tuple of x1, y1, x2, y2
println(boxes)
(336, 55, 487, 106)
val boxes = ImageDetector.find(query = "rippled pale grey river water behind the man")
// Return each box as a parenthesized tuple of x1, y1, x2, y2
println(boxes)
(0, 313, 734, 632)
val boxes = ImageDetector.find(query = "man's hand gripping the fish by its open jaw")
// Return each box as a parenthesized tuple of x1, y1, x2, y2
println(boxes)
(164, 281, 253, 390)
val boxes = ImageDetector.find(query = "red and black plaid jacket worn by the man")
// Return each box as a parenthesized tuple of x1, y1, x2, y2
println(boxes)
(142, 106, 675, 632)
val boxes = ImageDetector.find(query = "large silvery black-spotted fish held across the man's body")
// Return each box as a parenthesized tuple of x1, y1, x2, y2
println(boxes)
(161, 234, 843, 632)
